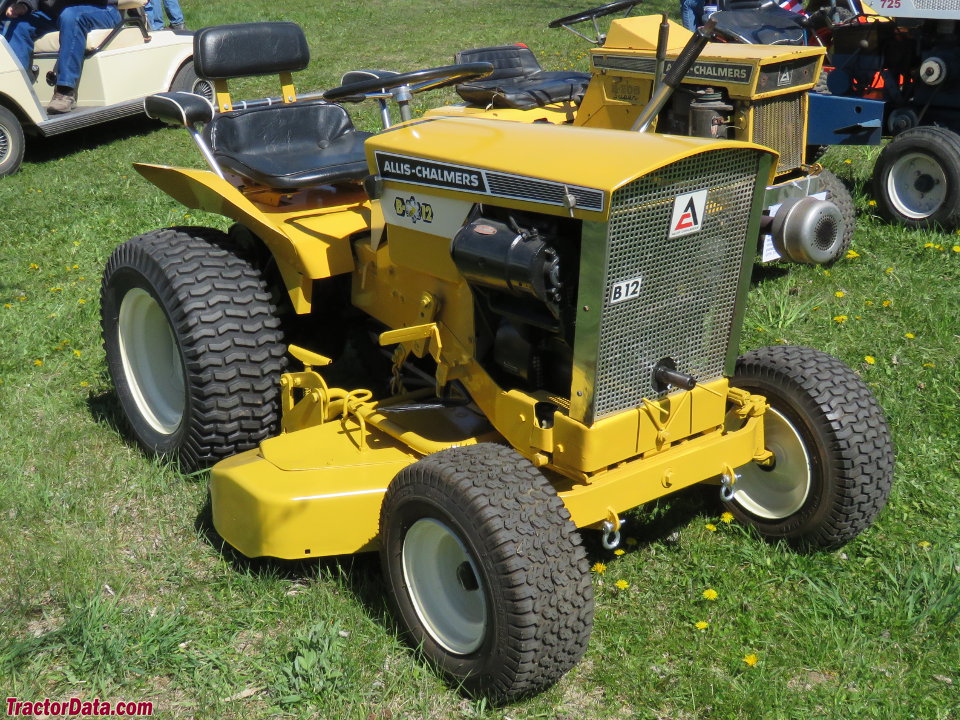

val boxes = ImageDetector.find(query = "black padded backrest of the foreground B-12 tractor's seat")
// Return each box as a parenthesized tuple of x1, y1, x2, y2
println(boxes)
(193, 22, 310, 80)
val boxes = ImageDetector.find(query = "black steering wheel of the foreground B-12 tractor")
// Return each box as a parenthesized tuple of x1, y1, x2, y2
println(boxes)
(323, 62, 493, 128)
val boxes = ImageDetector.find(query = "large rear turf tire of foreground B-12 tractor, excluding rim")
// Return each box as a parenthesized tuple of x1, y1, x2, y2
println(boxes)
(101, 228, 286, 472)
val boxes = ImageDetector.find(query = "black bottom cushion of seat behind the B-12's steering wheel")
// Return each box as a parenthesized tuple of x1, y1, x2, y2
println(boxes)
(457, 70, 590, 110)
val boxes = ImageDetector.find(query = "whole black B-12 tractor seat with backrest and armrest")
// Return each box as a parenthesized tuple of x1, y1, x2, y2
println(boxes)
(145, 22, 371, 190)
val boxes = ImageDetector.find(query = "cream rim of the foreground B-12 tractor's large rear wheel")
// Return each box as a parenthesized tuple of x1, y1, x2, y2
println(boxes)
(118, 288, 187, 435)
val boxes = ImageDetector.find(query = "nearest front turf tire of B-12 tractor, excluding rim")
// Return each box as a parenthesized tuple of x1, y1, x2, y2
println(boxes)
(380, 444, 593, 703)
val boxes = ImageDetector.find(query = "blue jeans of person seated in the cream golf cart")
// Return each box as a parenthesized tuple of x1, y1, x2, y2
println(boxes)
(3, 5, 120, 88)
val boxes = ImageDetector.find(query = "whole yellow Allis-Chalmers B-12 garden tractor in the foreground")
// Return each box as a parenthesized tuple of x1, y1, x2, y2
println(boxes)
(101, 23, 893, 702)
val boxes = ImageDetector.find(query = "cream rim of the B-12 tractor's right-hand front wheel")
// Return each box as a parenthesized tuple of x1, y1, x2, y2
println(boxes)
(733, 407, 811, 520)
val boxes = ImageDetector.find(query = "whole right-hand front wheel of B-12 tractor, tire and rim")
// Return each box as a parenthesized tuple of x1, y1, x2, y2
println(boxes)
(727, 346, 893, 550)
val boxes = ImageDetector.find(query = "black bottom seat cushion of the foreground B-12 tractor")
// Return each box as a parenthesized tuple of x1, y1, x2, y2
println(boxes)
(204, 101, 371, 190)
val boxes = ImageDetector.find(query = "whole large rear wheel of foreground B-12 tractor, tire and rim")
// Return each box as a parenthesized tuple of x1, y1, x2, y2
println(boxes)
(100, 228, 285, 472)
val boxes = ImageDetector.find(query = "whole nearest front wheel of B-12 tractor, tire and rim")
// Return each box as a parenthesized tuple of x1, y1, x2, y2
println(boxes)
(380, 444, 593, 702)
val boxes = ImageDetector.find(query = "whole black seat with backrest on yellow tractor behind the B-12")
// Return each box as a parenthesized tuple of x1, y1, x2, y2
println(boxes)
(455, 45, 590, 110)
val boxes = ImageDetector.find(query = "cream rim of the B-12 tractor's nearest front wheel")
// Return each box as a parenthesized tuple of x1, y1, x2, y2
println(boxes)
(402, 518, 487, 655)
